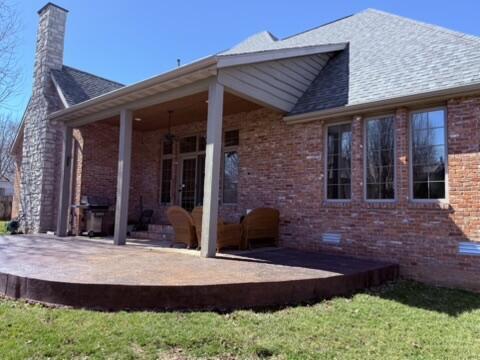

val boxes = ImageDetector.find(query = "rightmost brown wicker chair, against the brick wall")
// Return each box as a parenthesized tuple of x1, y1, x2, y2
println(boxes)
(242, 208, 280, 247)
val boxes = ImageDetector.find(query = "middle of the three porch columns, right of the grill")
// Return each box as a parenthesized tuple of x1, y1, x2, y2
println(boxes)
(113, 109, 133, 245)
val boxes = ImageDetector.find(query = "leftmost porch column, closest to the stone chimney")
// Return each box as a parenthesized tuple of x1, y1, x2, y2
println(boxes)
(56, 126, 73, 236)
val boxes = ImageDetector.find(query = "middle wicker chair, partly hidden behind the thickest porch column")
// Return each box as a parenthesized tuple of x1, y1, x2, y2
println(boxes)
(192, 206, 242, 251)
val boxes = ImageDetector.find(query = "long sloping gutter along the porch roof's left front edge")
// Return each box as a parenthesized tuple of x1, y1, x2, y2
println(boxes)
(48, 56, 217, 120)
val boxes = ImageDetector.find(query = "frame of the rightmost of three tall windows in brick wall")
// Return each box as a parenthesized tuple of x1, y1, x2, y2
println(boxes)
(408, 106, 449, 204)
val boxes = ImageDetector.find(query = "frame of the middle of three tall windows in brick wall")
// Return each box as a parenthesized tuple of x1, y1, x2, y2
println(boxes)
(363, 113, 398, 203)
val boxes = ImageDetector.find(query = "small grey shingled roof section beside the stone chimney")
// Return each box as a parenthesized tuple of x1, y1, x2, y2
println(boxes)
(52, 65, 124, 106)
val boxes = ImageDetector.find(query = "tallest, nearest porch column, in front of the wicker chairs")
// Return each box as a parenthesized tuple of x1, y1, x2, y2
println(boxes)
(201, 79, 223, 257)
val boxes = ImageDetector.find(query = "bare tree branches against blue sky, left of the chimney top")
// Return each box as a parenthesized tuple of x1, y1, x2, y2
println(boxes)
(0, 0, 20, 107)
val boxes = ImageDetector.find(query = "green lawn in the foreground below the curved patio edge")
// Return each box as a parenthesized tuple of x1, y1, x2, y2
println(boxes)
(0, 281, 480, 359)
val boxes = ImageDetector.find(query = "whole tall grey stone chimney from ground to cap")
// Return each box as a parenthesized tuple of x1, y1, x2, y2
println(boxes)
(20, 3, 68, 233)
